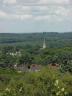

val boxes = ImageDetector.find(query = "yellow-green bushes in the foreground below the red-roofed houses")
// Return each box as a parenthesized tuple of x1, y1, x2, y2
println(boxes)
(0, 67, 72, 96)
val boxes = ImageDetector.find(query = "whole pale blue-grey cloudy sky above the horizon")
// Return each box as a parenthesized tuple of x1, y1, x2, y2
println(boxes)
(0, 0, 72, 33)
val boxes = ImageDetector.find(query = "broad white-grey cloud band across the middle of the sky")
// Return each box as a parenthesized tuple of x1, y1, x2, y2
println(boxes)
(0, 6, 72, 22)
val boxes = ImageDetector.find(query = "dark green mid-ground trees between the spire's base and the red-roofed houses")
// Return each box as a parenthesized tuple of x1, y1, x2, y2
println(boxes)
(0, 45, 72, 73)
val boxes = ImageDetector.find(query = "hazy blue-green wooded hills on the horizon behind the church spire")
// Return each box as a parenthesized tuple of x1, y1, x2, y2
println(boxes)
(0, 32, 72, 48)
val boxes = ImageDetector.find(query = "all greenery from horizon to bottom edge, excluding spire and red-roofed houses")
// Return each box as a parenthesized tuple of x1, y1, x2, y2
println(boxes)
(0, 32, 72, 96)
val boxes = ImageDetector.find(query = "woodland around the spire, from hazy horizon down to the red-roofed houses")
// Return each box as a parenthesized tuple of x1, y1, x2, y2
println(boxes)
(0, 33, 72, 72)
